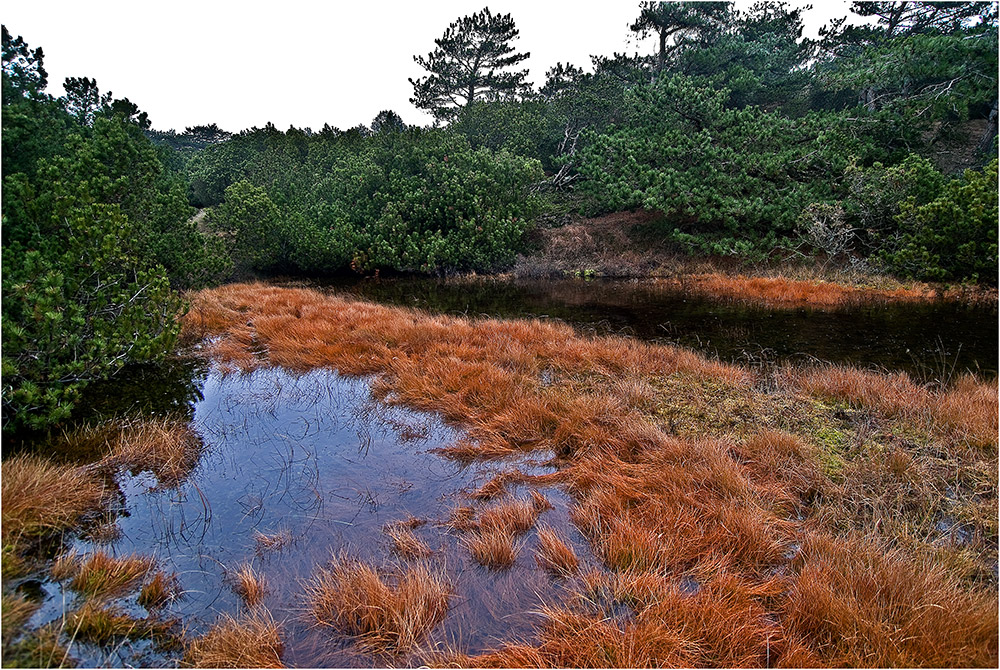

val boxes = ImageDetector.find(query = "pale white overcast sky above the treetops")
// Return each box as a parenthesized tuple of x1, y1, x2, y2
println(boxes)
(2, 0, 864, 131)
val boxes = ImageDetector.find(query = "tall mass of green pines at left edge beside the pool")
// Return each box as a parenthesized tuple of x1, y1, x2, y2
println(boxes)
(2, 29, 226, 432)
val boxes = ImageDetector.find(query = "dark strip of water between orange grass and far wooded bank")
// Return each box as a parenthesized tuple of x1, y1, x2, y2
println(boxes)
(294, 278, 998, 382)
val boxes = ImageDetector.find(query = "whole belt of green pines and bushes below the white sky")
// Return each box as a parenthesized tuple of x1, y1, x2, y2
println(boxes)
(3, 2, 997, 431)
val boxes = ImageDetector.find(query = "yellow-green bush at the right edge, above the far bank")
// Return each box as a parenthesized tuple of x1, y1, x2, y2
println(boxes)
(882, 160, 998, 283)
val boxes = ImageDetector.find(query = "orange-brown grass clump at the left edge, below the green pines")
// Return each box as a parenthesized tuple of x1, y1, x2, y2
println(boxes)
(0, 456, 104, 545)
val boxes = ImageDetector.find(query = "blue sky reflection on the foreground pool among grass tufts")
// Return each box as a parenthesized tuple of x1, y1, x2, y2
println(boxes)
(34, 369, 589, 666)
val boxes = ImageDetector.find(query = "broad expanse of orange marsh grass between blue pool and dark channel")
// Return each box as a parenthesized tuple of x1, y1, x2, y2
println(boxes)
(184, 284, 998, 667)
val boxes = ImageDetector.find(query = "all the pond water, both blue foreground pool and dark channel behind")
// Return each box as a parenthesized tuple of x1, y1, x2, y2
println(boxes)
(9, 280, 997, 667)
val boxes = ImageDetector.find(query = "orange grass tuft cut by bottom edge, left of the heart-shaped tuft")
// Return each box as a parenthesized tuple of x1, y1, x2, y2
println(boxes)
(184, 609, 284, 668)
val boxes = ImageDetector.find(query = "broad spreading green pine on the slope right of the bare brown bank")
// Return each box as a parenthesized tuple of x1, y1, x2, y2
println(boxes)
(580, 75, 892, 255)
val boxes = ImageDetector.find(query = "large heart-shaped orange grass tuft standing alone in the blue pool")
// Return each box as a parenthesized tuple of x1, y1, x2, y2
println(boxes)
(305, 557, 451, 652)
